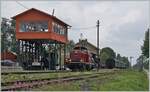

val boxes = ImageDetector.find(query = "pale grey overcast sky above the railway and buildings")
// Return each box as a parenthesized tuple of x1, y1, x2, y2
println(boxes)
(1, 1, 149, 64)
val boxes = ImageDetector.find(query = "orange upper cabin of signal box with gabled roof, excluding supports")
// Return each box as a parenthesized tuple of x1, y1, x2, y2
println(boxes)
(12, 8, 69, 43)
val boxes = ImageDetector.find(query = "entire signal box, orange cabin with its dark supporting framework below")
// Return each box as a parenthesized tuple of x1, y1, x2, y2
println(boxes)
(12, 8, 70, 69)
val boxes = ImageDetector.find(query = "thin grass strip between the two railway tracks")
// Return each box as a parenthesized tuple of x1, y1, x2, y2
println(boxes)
(1, 72, 93, 83)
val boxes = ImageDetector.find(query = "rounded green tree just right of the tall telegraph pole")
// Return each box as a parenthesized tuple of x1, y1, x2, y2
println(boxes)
(100, 47, 116, 62)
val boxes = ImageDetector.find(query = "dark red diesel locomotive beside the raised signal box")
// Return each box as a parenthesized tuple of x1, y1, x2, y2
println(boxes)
(65, 46, 94, 70)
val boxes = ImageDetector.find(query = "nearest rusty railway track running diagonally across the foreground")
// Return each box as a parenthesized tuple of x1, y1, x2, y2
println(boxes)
(1, 71, 118, 91)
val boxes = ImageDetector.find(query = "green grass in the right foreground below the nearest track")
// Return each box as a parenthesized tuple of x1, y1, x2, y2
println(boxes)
(32, 70, 148, 91)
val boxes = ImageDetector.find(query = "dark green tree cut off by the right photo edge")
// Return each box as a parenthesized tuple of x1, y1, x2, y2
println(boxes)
(141, 28, 149, 58)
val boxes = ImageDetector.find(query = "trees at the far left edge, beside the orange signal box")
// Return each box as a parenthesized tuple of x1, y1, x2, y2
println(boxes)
(1, 18, 16, 52)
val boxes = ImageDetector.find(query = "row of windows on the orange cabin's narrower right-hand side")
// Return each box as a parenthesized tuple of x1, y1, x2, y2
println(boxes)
(52, 22, 66, 35)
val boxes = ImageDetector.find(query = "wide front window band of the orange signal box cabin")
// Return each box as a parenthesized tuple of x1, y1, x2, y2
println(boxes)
(20, 21, 48, 32)
